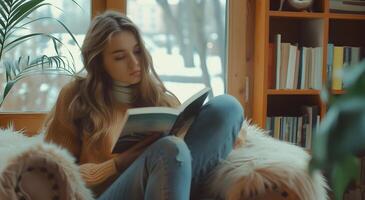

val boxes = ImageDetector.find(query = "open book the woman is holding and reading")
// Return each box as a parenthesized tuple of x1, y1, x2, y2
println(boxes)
(112, 88, 210, 153)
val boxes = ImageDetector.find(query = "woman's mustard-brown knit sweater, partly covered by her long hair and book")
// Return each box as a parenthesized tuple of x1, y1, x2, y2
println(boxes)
(46, 82, 127, 195)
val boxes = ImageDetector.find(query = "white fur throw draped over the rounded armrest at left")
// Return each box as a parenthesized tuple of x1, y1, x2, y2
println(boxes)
(0, 129, 93, 200)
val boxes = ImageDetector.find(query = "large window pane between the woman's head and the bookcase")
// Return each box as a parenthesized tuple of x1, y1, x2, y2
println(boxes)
(127, 0, 226, 101)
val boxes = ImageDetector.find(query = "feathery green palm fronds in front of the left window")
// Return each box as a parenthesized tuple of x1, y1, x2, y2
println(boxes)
(0, 0, 80, 105)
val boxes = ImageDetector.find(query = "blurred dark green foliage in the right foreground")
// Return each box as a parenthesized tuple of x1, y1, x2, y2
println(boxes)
(309, 60, 365, 200)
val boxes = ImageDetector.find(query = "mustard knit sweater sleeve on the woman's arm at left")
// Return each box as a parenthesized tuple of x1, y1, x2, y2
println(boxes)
(45, 85, 118, 188)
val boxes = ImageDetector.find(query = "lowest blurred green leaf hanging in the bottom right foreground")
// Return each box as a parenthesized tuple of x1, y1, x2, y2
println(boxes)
(331, 156, 360, 200)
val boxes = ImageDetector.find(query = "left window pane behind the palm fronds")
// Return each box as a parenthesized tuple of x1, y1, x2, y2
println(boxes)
(0, 0, 91, 112)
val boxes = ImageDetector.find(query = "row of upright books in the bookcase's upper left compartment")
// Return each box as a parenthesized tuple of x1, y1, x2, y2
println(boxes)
(269, 34, 323, 90)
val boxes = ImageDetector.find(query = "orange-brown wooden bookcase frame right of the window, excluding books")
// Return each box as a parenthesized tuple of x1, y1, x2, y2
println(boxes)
(252, 0, 365, 128)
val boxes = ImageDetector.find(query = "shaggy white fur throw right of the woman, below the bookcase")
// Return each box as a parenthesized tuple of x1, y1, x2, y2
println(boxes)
(206, 121, 328, 200)
